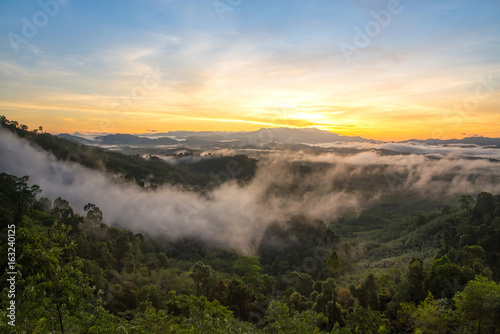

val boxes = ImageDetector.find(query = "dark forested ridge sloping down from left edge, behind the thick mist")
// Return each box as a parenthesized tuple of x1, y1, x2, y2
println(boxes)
(0, 116, 256, 191)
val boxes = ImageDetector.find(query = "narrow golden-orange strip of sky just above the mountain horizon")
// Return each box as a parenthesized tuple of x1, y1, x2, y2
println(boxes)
(0, 90, 500, 140)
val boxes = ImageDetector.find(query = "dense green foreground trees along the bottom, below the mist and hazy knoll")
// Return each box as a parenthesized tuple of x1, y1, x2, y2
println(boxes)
(0, 173, 500, 333)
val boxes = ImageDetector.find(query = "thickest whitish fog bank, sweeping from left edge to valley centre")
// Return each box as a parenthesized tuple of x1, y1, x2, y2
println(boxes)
(0, 130, 372, 254)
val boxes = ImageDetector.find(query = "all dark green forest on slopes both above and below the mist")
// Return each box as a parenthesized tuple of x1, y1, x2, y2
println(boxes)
(0, 117, 500, 333)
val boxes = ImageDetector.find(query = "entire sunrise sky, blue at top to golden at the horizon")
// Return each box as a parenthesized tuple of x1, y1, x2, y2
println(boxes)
(0, 0, 500, 140)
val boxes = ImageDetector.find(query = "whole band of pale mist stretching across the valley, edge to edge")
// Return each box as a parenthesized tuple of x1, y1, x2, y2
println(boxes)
(0, 129, 500, 254)
